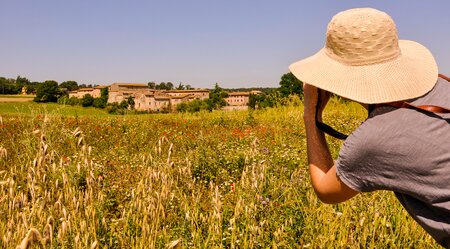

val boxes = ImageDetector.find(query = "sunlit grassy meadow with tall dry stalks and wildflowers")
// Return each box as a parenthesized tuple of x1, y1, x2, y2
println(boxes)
(0, 101, 438, 248)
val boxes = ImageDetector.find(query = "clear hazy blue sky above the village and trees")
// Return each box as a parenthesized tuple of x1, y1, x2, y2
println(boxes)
(0, 0, 450, 88)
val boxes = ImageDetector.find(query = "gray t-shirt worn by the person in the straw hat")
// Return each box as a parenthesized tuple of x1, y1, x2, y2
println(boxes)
(336, 78, 450, 248)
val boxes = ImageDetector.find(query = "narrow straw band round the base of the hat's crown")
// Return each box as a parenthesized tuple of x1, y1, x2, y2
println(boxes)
(325, 48, 402, 66)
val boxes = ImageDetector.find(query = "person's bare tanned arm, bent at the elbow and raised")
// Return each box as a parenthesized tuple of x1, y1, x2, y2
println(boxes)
(303, 84, 358, 204)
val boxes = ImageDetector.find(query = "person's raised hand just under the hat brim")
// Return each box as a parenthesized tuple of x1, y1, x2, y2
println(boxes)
(303, 83, 330, 121)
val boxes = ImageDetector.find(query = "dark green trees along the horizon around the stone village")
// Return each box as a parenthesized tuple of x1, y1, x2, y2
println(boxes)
(0, 73, 303, 112)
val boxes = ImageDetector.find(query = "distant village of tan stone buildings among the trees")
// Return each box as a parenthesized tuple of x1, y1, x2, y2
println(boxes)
(69, 83, 261, 111)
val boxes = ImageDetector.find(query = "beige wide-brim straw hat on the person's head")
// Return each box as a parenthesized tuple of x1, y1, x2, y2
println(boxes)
(289, 8, 438, 104)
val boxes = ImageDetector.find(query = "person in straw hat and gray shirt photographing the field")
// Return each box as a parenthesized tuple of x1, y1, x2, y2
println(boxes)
(289, 8, 450, 248)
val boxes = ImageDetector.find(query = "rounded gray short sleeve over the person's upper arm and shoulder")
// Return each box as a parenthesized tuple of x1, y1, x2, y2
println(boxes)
(336, 104, 450, 198)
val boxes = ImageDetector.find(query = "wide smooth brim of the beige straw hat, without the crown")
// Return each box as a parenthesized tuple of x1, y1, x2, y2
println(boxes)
(289, 40, 438, 104)
